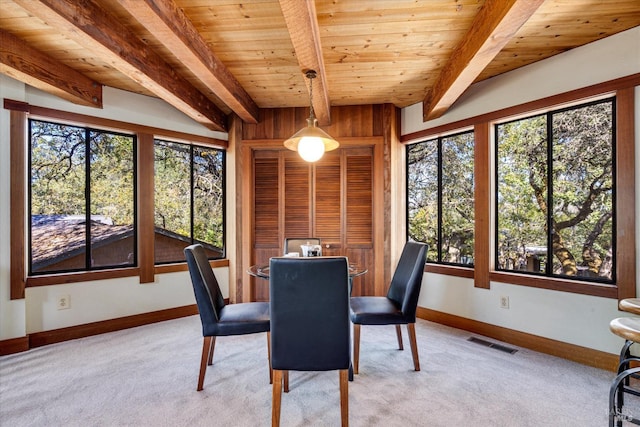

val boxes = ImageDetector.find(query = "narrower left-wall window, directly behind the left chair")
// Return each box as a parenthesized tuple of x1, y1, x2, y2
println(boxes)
(154, 140, 225, 264)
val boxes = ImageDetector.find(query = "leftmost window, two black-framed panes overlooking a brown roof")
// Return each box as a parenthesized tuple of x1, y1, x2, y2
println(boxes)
(29, 120, 137, 275)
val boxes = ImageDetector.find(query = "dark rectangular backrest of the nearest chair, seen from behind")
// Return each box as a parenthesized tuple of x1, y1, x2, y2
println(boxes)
(269, 257, 351, 371)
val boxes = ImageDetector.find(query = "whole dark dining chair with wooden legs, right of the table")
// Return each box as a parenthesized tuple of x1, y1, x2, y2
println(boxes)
(351, 242, 427, 374)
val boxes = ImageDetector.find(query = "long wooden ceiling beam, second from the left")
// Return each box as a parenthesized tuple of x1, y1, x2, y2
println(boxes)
(15, 0, 227, 132)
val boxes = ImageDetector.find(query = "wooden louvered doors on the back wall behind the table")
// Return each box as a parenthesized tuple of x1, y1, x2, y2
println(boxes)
(252, 147, 375, 301)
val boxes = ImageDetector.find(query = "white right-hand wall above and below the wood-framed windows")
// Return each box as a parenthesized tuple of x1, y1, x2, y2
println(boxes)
(402, 27, 640, 353)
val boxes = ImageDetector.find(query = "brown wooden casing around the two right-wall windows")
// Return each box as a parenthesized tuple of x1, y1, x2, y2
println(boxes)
(400, 74, 640, 300)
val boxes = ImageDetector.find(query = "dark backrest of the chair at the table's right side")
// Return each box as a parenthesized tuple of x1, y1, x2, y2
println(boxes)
(387, 242, 427, 323)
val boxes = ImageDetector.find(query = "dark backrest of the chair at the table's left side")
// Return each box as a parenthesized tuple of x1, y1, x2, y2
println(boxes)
(184, 244, 225, 336)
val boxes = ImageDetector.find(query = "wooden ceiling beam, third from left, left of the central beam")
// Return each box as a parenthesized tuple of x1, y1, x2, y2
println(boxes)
(118, 0, 260, 123)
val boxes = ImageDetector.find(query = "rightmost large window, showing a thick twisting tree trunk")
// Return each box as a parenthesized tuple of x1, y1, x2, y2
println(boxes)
(495, 99, 616, 283)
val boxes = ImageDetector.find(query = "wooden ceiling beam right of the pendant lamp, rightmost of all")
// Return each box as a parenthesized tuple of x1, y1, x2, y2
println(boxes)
(422, 0, 544, 121)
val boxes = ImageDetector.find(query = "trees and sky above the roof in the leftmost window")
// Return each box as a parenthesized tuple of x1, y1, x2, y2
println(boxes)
(30, 120, 135, 225)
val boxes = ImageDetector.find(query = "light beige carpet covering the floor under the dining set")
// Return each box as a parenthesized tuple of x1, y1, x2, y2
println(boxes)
(0, 316, 614, 427)
